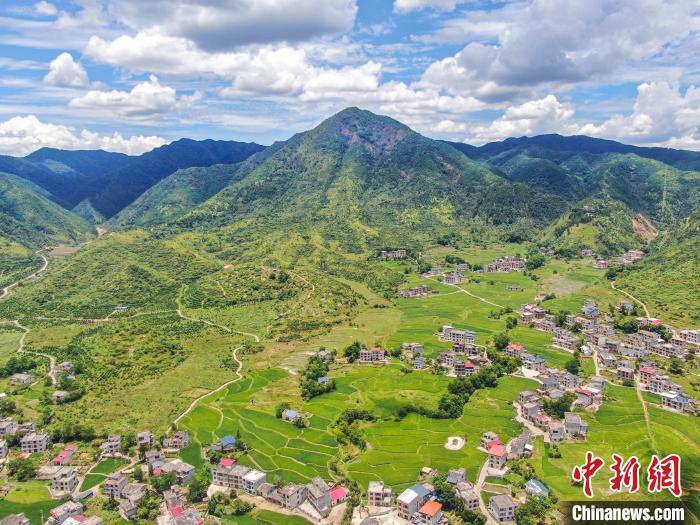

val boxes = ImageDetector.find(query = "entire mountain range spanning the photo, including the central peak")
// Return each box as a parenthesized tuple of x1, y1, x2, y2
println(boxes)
(0, 108, 700, 260)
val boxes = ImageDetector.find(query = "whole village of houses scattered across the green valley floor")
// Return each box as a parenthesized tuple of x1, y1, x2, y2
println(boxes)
(0, 250, 700, 525)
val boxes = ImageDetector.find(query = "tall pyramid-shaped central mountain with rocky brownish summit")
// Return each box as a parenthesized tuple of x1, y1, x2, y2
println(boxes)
(176, 108, 563, 251)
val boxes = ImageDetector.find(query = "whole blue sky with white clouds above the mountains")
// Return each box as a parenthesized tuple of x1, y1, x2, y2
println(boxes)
(0, 0, 700, 155)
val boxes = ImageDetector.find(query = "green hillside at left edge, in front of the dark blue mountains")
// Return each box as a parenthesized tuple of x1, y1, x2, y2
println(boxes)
(0, 173, 94, 248)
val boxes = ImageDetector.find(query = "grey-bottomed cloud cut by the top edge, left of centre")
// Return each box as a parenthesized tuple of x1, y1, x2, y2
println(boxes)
(109, 0, 357, 51)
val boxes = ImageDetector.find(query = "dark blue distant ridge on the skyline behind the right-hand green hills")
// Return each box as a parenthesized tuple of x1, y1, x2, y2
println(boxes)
(446, 133, 700, 170)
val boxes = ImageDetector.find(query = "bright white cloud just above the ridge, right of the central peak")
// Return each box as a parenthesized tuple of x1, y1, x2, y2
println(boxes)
(468, 95, 575, 144)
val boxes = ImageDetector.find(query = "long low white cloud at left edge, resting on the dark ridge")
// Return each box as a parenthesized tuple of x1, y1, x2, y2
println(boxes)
(0, 115, 168, 155)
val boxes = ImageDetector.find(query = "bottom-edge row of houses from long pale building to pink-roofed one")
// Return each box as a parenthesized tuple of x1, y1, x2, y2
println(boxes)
(210, 458, 349, 519)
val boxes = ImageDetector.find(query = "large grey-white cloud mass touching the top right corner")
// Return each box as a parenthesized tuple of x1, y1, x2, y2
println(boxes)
(421, 0, 700, 100)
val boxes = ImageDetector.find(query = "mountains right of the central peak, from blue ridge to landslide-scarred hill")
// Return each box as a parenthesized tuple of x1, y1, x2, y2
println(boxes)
(450, 135, 700, 254)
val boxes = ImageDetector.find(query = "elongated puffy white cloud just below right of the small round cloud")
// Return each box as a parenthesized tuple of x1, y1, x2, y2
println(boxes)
(70, 75, 178, 118)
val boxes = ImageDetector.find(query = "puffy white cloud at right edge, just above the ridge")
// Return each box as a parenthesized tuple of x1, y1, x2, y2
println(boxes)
(580, 82, 700, 149)
